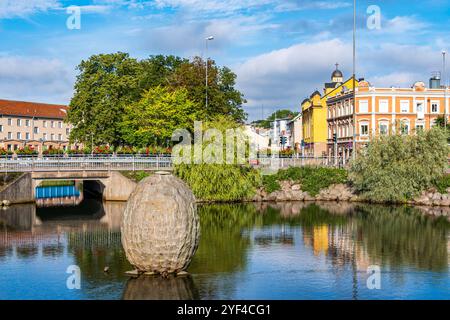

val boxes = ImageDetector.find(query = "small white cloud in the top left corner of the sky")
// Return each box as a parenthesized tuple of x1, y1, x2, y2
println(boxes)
(0, 0, 61, 19)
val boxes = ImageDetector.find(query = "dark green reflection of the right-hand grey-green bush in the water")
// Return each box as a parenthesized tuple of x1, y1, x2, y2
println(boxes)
(354, 205, 449, 271)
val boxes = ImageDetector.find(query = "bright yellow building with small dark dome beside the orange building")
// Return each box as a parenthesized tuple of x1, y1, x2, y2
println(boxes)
(301, 64, 358, 157)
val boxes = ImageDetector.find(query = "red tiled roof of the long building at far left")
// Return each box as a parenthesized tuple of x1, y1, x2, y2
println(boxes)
(0, 99, 68, 119)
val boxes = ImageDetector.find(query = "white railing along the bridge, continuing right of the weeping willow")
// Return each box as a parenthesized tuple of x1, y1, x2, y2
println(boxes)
(0, 156, 345, 172)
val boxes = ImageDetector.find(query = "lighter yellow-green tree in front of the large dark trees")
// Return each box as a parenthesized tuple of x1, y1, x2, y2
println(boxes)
(121, 86, 204, 147)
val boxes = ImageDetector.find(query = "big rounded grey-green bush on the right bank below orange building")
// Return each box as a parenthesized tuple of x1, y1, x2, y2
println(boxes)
(350, 128, 449, 202)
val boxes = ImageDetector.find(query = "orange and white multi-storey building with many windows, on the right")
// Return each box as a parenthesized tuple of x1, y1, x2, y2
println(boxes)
(327, 79, 450, 158)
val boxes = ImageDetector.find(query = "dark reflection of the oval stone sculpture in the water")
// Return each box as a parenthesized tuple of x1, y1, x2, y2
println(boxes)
(123, 276, 199, 300)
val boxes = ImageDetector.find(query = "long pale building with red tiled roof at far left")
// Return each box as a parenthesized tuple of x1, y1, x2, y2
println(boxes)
(0, 100, 71, 152)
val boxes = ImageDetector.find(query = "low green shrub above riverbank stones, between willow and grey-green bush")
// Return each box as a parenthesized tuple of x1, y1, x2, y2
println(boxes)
(263, 167, 347, 196)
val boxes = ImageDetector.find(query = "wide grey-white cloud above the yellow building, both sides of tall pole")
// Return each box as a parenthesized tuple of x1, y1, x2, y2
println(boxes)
(235, 39, 442, 120)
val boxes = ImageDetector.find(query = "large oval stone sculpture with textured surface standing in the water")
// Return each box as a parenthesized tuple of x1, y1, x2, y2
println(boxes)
(121, 174, 200, 275)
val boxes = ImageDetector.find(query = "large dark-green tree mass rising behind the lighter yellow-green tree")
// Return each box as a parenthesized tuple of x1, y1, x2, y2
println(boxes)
(67, 52, 246, 146)
